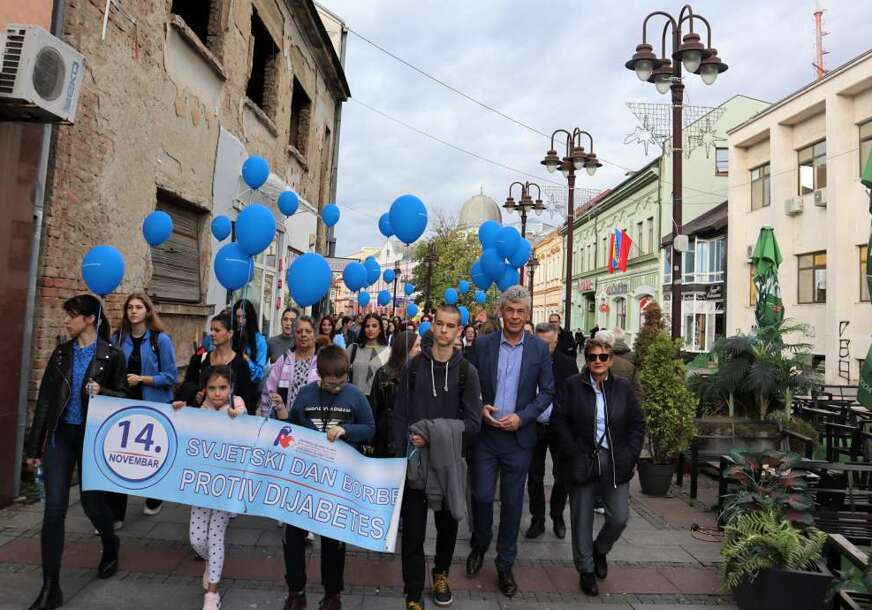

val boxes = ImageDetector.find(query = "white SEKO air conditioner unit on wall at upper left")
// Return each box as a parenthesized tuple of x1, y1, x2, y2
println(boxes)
(0, 25, 85, 123)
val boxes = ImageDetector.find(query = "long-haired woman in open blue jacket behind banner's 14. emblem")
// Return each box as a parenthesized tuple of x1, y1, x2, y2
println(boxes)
(108, 292, 178, 529)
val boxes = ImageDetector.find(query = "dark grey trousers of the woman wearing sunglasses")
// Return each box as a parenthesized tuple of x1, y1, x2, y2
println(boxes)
(569, 449, 630, 572)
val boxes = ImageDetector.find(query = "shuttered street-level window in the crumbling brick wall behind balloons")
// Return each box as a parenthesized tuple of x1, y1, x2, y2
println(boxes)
(149, 189, 206, 303)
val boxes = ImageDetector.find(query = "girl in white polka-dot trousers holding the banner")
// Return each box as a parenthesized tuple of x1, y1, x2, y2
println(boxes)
(173, 365, 246, 610)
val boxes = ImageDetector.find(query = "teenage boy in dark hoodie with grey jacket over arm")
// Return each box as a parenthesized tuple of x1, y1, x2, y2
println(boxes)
(393, 305, 482, 610)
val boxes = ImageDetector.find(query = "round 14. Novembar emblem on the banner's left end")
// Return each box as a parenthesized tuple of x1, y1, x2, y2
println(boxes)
(94, 406, 178, 489)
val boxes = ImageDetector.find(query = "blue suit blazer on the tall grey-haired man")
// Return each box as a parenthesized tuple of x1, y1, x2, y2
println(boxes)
(469, 332, 554, 449)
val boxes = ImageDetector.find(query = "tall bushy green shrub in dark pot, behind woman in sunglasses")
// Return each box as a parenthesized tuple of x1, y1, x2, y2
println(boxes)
(639, 330, 697, 496)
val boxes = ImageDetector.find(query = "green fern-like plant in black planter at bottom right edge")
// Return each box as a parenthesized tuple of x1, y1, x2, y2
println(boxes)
(721, 510, 832, 610)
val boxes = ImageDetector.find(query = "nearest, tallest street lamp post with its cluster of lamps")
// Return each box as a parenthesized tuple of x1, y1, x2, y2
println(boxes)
(625, 4, 727, 337)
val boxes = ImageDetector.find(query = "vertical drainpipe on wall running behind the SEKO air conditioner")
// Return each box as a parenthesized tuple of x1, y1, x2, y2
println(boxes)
(12, 0, 66, 498)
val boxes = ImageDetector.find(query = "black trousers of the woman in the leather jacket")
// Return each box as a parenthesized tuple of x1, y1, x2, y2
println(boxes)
(41, 424, 115, 578)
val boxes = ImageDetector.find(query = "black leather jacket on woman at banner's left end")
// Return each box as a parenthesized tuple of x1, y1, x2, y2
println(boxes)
(25, 339, 127, 457)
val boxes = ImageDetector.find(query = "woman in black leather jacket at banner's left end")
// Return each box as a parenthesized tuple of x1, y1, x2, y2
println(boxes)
(25, 294, 127, 610)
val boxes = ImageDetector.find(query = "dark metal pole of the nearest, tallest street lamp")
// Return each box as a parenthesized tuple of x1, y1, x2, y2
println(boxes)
(671, 27, 684, 338)
